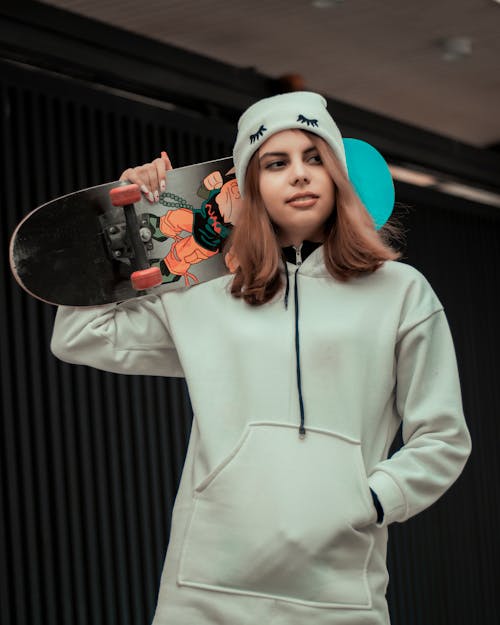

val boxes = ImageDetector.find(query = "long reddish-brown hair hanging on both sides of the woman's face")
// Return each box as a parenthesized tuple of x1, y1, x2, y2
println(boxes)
(225, 133, 401, 306)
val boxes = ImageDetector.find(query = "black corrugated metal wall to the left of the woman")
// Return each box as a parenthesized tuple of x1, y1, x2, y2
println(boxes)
(0, 59, 233, 625)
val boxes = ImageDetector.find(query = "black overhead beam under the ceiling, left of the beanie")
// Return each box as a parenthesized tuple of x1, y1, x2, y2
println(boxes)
(0, 2, 268, 114)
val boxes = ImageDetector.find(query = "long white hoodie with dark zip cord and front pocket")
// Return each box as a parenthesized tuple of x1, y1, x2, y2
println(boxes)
(52, 247, 470, 625)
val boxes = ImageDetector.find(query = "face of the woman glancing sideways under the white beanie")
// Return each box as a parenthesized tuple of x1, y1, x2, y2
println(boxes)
(257, 130, 335, 245)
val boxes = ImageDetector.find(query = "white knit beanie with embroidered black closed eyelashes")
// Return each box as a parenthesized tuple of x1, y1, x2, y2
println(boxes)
(233, 91, 347, 195)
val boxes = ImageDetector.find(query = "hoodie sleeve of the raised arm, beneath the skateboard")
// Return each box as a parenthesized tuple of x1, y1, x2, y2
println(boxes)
(51, 295, 184, 377)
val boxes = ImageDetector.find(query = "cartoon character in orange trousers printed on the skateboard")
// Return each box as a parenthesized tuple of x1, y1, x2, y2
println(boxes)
(149, 169, 243, 286)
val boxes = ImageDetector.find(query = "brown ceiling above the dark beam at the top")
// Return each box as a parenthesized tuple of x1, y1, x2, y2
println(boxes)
(42, 0, 500, 147)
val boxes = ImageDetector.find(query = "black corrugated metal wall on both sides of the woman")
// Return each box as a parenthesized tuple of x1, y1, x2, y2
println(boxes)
(0, 56, 500, 625)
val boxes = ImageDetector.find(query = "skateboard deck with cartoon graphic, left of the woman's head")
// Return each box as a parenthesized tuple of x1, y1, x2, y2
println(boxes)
(10, 158, 241, 306)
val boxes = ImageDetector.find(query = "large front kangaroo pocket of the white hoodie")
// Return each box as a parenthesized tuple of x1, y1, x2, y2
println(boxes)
(178, 423, 375, 609)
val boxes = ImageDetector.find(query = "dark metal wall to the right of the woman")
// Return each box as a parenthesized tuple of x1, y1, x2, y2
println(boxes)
(389, 184, 500, 625)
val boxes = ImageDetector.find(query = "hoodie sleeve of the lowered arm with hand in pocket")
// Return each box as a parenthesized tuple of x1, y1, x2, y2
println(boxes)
(369, 286, 471, 526)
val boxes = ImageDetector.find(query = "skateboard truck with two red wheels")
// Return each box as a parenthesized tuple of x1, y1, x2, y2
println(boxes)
(107, 184, 163, 291)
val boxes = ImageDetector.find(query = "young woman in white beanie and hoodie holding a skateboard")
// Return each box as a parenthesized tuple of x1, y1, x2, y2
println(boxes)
(52, 92, 470, 625)
